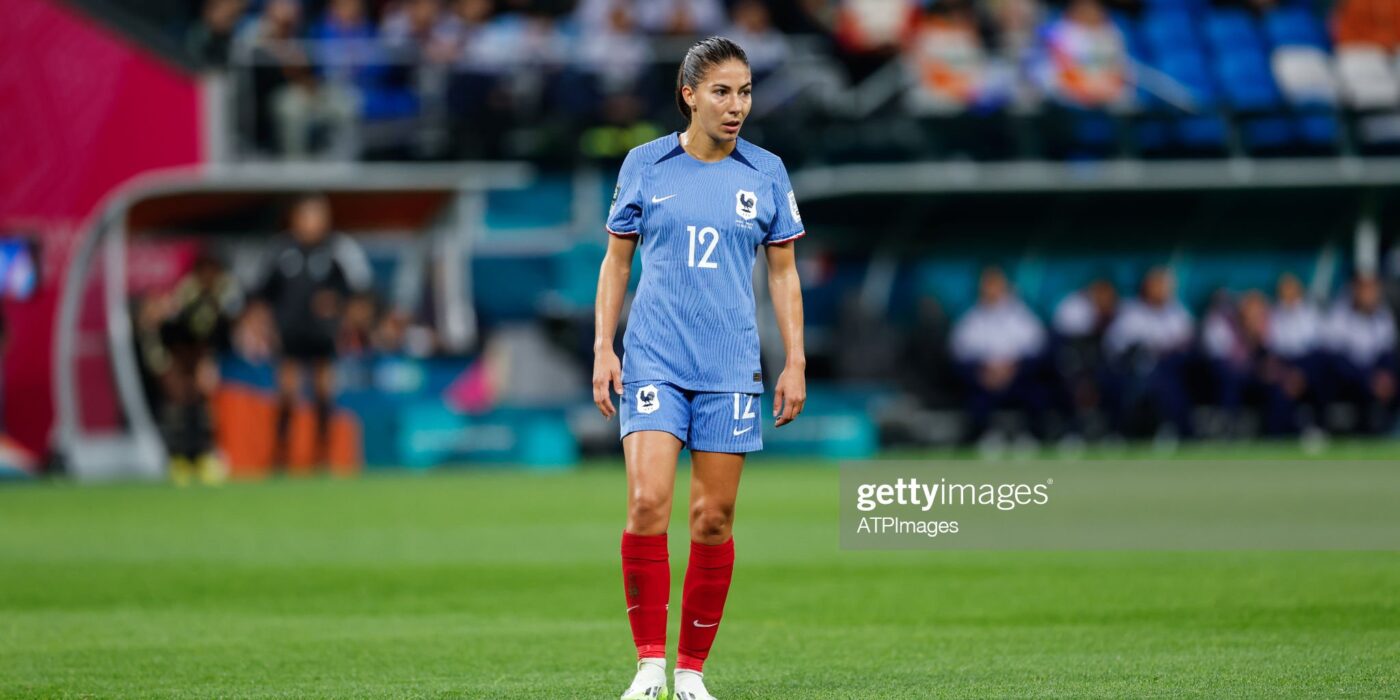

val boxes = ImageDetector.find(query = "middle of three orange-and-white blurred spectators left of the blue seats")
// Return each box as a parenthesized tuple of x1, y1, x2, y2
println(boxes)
(904, 0, 1011, 113)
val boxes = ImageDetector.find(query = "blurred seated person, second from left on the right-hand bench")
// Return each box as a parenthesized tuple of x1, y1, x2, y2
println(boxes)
(1051, 279, 1119, 426)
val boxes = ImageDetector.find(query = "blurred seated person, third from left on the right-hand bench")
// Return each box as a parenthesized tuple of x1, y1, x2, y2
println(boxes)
(1103, 267, 1193, 437)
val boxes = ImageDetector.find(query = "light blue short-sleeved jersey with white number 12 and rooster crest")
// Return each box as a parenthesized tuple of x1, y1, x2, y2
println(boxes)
(608, 133, 805, 393)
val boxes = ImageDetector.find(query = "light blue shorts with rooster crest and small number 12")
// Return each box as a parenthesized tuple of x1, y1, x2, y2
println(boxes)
(620, 382, 763, 452)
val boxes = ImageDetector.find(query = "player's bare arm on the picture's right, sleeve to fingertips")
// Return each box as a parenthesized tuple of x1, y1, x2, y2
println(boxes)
(764, 241, 806, 427)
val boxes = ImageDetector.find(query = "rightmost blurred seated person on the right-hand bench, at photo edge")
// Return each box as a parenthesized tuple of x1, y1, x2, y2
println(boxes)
(1326, 273, 1396, 433)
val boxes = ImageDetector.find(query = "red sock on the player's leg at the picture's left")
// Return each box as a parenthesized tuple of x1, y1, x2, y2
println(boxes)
(622, 531, 671, 659)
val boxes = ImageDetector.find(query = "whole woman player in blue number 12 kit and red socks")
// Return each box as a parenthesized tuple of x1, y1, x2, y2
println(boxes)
(594, 36, 806, 700)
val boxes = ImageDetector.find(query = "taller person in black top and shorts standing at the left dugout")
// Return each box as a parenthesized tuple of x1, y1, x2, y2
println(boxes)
(258, 195, 371, 473)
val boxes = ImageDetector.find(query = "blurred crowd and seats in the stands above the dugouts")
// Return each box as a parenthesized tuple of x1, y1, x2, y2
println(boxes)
(109, 0, 1400, 161)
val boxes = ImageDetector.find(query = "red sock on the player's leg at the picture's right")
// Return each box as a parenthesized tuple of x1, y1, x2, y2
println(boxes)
(676, 538, 734, 671)
